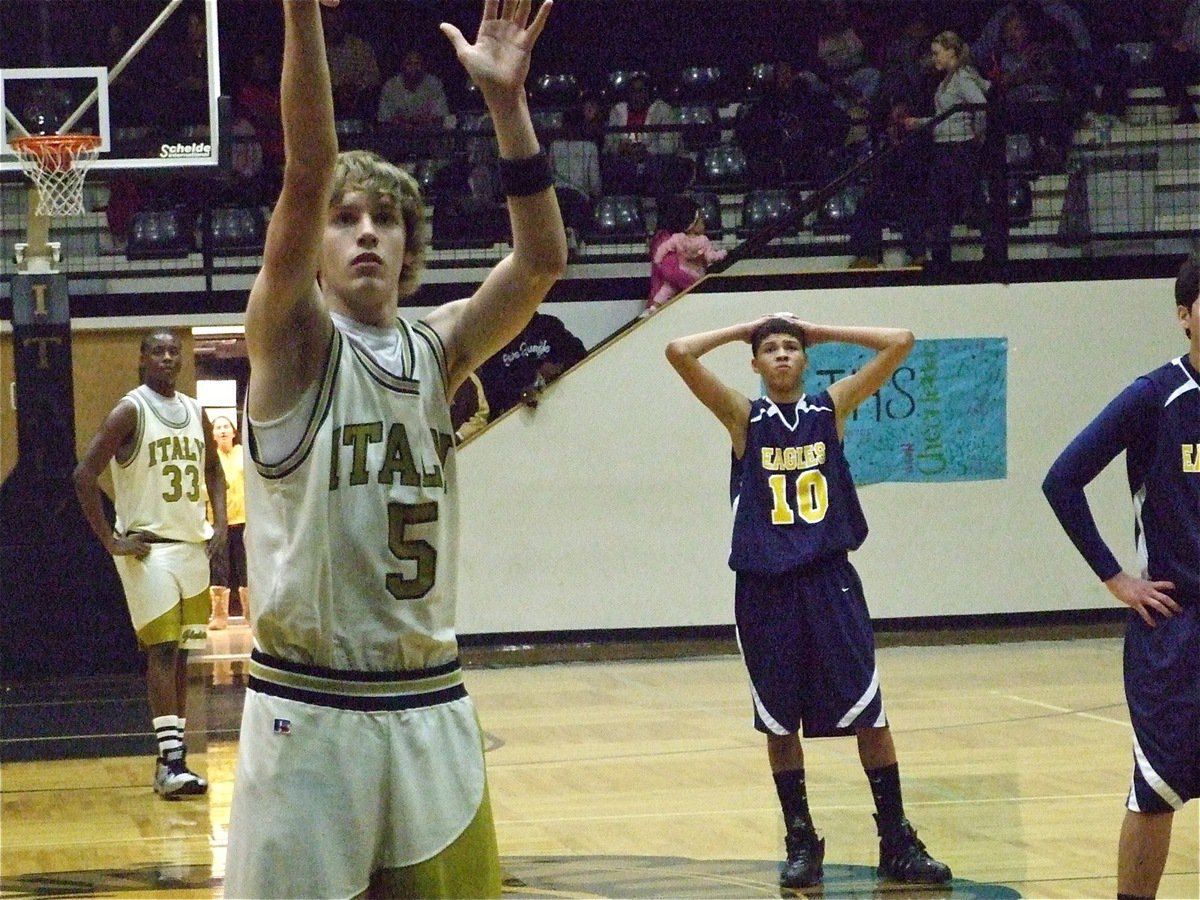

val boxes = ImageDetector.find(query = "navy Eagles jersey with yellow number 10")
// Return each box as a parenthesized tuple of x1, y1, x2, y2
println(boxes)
(730, 391, 866, 575)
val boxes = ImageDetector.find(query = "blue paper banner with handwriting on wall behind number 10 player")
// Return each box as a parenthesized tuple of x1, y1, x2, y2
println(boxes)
(804, 337, 1008, 485)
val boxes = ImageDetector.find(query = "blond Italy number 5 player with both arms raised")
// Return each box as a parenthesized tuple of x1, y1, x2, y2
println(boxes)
(224, 0, 566, 898)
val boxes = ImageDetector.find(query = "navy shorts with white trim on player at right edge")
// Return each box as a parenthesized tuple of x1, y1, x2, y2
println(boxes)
(1124, 598, 1200, 812)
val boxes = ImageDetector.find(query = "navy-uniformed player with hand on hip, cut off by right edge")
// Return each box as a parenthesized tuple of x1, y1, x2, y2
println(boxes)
(1042, 259, 1200, 898)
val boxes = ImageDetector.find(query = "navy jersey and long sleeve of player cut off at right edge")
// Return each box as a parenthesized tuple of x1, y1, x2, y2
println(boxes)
(1043, 356, 1200, 602)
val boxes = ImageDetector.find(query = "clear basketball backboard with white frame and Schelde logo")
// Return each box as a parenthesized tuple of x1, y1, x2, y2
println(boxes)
(0, 0, 222, 172)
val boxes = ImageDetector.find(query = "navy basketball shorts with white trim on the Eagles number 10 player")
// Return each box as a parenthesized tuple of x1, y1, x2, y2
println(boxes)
(733, 557, 888, 738)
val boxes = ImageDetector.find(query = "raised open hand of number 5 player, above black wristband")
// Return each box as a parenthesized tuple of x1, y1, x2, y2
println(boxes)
(439, 0, 553, 107)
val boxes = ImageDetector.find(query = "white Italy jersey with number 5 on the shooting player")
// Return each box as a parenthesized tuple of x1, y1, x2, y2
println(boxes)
(246, 320, 458, 672)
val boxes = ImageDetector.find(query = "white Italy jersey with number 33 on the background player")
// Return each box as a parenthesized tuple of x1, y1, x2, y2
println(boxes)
(109, 384, 212, 542)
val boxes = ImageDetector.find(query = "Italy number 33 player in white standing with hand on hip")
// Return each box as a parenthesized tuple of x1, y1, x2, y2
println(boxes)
(74, 330, 227, 800)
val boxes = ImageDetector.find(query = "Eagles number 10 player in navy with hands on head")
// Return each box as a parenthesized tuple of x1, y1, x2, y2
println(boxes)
(666, 313, 950, 888)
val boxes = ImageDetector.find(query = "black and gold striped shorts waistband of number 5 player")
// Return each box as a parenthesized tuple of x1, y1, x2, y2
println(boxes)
(246, 649, 467, 712)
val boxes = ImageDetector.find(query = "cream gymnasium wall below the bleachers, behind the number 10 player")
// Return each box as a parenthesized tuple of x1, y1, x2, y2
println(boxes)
(458, 278, 1187, 635)
